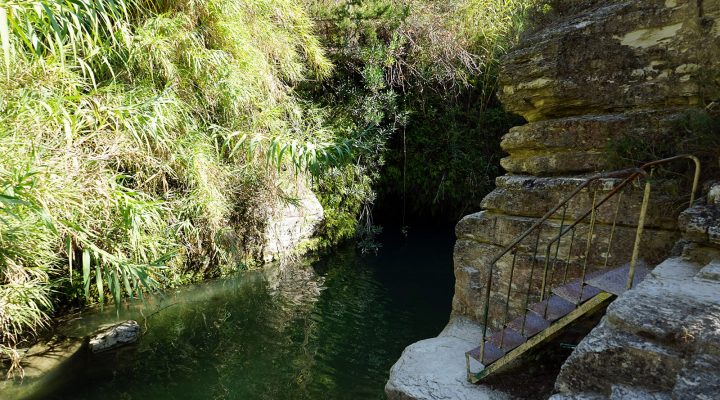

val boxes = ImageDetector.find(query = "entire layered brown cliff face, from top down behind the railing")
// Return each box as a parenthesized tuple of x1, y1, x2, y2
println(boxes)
(453, 0, 720, 328)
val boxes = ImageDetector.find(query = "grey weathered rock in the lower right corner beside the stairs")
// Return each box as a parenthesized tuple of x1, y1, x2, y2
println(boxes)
(554, 185, 720, 400)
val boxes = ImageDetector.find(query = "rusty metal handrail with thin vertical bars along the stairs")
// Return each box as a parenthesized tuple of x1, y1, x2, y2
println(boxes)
(480, 155, 700, 360)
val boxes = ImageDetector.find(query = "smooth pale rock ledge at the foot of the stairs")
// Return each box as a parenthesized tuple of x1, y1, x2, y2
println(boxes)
(385, 317, 510, 400)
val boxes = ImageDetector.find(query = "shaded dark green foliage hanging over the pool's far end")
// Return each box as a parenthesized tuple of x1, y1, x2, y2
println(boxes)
(309, 0, 534, 223)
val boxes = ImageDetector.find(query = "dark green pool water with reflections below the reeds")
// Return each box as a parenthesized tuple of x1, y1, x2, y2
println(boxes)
(49, 227, 453, 399)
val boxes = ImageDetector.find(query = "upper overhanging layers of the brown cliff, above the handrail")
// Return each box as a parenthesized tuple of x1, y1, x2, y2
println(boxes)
(500, 0, 720, 175)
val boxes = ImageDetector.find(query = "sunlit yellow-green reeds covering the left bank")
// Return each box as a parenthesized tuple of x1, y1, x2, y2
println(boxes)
(0, 0, 342, 366)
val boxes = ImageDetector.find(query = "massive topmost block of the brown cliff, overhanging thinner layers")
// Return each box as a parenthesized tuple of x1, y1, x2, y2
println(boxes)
(501, 0, 720, 122)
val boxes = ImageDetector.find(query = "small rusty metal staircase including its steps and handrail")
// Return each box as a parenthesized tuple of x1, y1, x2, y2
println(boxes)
(465, 155, 700, 383)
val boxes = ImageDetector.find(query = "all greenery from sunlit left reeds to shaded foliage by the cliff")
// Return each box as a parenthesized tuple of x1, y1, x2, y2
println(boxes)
(0, 0, 529, 368)
